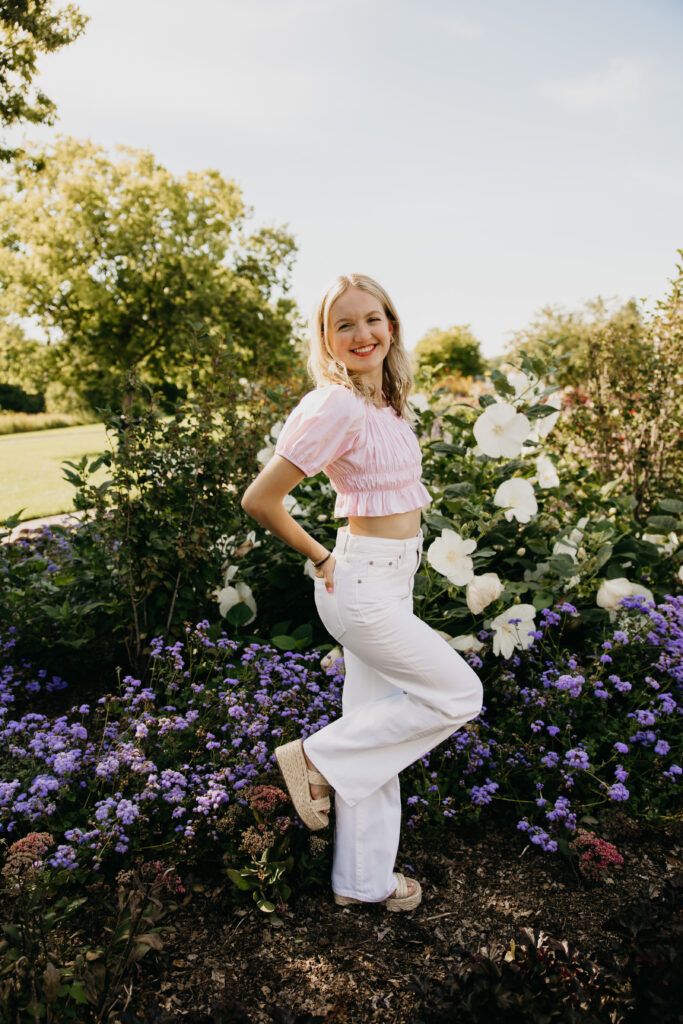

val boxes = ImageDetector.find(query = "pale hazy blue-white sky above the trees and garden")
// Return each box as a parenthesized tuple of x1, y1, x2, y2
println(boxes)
(5, 0, 683, 356)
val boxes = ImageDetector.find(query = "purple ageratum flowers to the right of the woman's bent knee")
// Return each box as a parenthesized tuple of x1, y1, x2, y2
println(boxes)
(403, 595, 683, 853)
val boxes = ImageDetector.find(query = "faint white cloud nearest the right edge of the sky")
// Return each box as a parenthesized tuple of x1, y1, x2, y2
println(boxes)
(541, 57, 646, 111)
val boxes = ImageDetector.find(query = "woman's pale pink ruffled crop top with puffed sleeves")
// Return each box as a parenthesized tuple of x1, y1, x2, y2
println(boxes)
(275, 384, 431, 518)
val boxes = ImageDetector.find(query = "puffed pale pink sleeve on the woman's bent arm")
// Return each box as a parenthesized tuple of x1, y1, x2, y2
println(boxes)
(275, 384, 365, 476)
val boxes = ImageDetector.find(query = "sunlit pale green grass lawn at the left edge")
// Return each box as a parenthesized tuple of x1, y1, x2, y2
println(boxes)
(0, 423, 106, 519)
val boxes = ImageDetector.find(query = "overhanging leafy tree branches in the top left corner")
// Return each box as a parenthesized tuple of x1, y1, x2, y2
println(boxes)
(0, 0, 89, 161)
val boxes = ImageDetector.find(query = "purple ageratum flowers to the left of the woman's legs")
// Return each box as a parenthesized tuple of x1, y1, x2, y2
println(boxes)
(0, 623, 343, 869)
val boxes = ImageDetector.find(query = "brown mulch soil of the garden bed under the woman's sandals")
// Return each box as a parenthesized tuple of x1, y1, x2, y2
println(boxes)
(113, 815, 683, 1024)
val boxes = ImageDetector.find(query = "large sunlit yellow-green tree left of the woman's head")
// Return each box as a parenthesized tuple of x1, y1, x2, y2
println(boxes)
(0, 138, 295, 408)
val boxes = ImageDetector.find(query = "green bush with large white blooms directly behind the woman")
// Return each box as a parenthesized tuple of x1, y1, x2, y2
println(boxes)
(219, 345, 683, 657)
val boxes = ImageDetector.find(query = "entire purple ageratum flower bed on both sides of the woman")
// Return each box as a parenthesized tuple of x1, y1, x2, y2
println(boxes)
(0, 597, 683, 869)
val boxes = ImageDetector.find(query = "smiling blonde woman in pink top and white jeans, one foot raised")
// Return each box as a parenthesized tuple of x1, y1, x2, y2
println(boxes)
(242, 274, 482, 910)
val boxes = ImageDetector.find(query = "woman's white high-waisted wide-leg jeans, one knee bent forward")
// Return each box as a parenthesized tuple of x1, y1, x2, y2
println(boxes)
(304, 526, 482, 902)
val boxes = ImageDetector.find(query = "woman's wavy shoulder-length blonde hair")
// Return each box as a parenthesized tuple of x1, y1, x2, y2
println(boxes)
(307, 273, 416, 423)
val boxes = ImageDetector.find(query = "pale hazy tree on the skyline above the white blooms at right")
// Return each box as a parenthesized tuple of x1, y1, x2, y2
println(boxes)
(492, 296, 645, 387)
